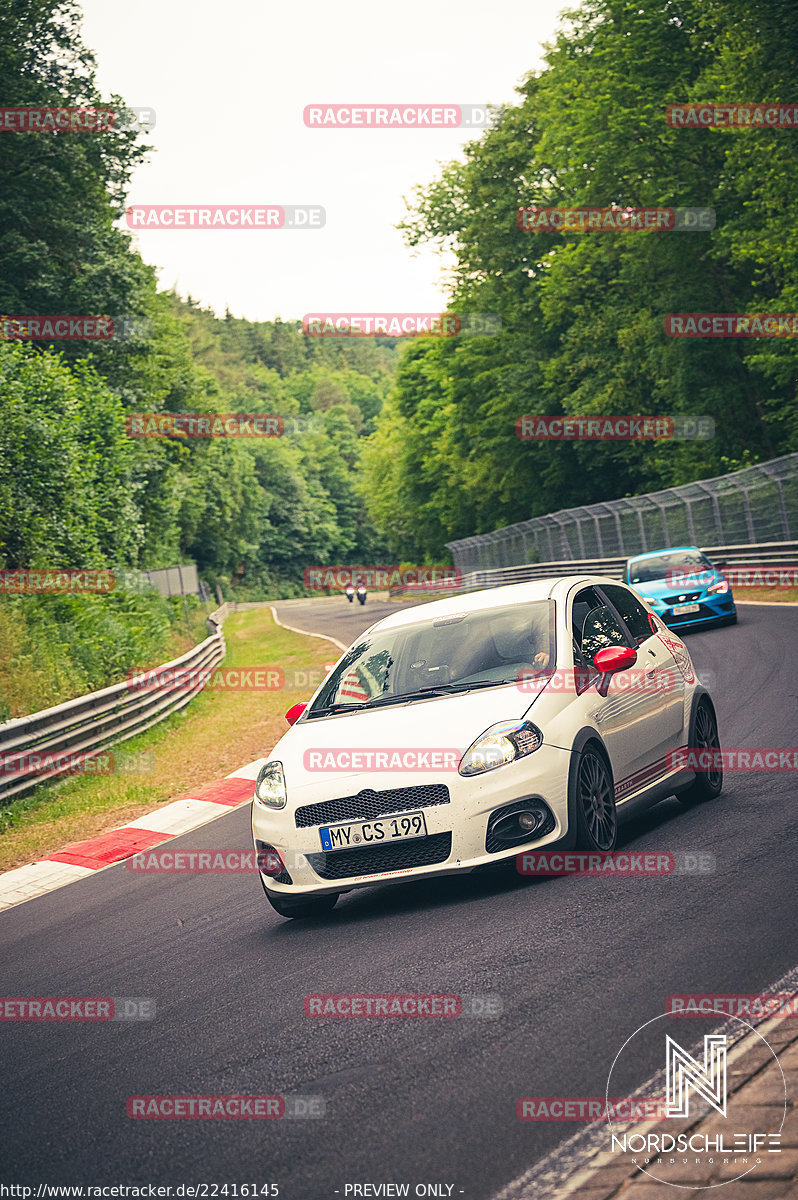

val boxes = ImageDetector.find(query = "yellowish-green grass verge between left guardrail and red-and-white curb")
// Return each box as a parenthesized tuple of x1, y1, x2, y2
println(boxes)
(0, 607, 338, 871)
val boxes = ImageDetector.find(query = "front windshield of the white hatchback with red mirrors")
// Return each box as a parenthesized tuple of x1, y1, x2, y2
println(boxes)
(306, 600, 554, 718)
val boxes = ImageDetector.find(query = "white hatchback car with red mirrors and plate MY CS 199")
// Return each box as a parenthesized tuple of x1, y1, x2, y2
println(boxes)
(252, 576, 722, 917)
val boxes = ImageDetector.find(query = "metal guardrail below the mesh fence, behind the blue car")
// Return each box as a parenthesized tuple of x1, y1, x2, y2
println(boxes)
(390, 541, 798, 600)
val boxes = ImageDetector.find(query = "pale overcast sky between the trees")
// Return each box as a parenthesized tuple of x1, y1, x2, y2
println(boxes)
(83, 0, 563, 320)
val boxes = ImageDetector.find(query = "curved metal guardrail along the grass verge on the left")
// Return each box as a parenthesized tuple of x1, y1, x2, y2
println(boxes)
(0, 604, 233, 804)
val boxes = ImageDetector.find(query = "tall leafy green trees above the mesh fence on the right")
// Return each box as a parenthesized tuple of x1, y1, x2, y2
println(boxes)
(365, 0, 798, 554)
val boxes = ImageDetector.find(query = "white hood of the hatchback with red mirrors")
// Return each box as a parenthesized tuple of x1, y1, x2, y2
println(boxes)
(269, 684, 536, 806)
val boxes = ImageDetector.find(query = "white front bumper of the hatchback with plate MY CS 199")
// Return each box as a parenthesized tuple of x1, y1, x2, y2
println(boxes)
(252, 745, 570, 895)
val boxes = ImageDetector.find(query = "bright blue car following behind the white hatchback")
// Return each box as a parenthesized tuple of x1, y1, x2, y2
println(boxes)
(626, 546, 737, 629)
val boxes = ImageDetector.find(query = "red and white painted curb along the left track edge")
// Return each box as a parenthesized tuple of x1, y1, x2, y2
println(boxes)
(0, 758, 266, 912)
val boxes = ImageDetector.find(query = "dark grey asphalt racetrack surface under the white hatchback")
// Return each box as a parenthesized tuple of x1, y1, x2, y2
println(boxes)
(0, 601, 798, 1200)
